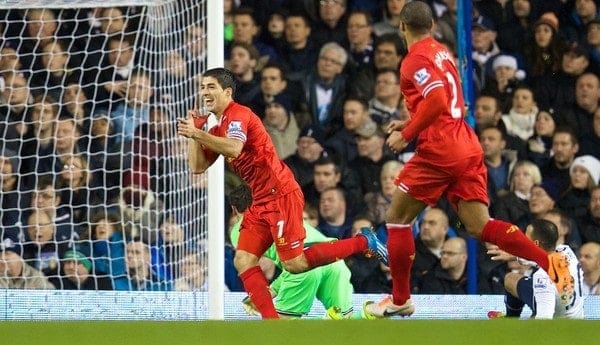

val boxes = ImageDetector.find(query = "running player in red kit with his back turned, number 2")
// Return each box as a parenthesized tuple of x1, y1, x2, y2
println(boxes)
(363, 1, 573, 318)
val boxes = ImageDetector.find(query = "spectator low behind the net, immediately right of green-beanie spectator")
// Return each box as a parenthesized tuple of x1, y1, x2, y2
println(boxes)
(125, 238, 173, 291)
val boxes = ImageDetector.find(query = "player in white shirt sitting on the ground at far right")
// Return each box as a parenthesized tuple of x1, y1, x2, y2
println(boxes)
(488, 219, 584, 319)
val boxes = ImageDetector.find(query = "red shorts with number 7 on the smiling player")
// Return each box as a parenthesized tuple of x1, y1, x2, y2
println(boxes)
(237, 190, 306, 261)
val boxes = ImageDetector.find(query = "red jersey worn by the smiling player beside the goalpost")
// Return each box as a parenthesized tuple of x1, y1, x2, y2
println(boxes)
(209, 102, 300, 204)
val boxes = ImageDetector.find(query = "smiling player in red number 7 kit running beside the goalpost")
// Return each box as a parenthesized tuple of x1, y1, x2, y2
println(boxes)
(177, 68, 387, 318)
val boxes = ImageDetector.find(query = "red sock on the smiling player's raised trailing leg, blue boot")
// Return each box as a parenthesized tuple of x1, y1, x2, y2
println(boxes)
(304, 236, 367, 268)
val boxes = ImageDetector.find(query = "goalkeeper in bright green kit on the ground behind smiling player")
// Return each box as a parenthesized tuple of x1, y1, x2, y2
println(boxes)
(228, 184, 360, 320)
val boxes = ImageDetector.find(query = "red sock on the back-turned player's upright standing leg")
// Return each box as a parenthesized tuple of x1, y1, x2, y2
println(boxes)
(386, 224, 415, 305)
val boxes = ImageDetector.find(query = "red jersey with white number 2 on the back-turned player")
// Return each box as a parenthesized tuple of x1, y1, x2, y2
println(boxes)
(400, 37, 483, 161)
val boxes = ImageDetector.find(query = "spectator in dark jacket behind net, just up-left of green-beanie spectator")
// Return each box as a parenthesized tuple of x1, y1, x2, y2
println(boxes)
(23, 210, 74, 287)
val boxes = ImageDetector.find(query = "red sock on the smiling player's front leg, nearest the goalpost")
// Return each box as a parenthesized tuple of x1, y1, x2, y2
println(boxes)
(240, 266, 279, 319)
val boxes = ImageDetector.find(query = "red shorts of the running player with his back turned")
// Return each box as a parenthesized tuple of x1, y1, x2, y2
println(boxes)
(395, 154, 489, 210)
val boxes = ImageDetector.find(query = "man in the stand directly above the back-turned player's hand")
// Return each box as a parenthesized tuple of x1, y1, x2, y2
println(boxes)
(369, 68, 408, 127)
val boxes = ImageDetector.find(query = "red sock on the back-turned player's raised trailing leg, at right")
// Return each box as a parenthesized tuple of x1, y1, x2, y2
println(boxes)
(481, 219, 549, 272)
